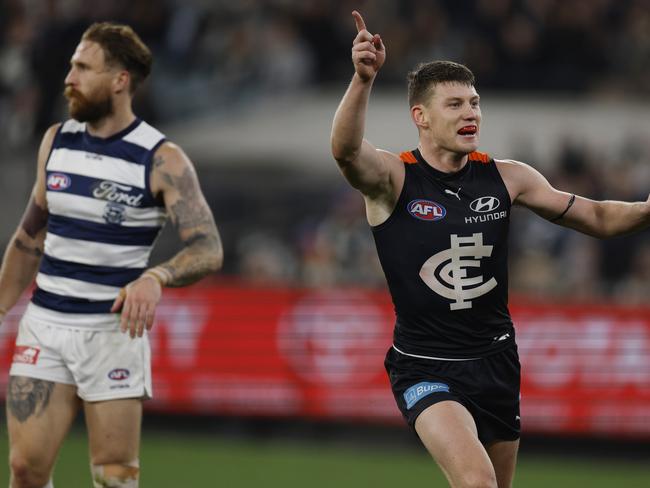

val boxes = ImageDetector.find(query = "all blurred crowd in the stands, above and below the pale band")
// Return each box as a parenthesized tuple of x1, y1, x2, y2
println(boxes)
(0, 0, 650, 304)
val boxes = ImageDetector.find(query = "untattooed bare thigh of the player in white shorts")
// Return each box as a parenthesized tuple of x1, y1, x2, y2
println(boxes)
(84, 398, 142, 465)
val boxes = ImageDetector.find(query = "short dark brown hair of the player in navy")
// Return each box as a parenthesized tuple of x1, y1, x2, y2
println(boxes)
(408, 61, 475, 107)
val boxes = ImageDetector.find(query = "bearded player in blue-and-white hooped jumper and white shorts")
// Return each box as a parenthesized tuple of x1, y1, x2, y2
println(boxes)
(0, 23, 223, 488)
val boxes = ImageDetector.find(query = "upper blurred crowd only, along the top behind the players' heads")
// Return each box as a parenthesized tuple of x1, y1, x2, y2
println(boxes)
(0, 0, 650, 142)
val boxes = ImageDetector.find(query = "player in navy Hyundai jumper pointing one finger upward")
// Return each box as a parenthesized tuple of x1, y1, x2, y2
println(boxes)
(331, 11, 650, 488)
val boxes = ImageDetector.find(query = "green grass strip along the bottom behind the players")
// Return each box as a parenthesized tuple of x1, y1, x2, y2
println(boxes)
(0, 426, 650, 488)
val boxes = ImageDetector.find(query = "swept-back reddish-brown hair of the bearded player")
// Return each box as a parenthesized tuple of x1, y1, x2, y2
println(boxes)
(81, 22, 153, 93)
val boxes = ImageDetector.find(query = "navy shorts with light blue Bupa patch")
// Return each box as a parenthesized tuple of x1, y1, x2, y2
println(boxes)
(384, 343, 521, 445)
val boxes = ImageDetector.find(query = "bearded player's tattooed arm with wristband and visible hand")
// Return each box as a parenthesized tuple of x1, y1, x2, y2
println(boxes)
(113, 142, 223, 337)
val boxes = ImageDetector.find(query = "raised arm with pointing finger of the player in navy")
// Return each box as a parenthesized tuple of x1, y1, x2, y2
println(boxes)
(331, 11, 399, 198)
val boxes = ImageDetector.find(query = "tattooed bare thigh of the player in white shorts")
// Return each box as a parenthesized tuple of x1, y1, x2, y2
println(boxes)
(6, 376, 80, 471)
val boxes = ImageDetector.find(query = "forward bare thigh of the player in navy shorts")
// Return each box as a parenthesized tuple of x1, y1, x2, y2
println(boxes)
(415, 401, 497, 487)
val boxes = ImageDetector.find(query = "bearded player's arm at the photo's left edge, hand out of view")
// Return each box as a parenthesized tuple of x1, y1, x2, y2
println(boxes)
(0, 124, 58, 323)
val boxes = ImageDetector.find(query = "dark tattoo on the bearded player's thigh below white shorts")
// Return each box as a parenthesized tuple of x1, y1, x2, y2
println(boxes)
(7, 376, 54, 423)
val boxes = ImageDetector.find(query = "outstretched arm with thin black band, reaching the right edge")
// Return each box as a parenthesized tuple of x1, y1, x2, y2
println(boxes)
(497, 161, 650, 238)
